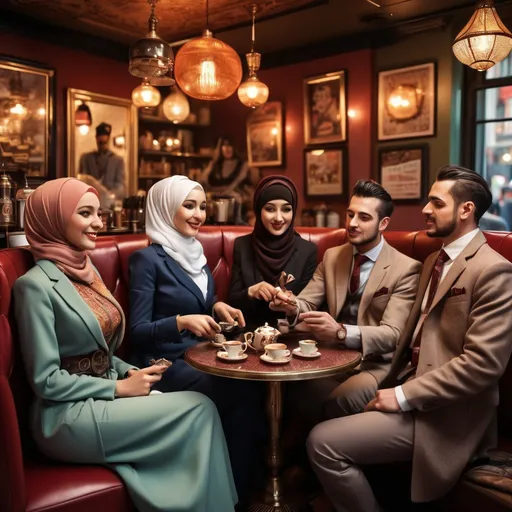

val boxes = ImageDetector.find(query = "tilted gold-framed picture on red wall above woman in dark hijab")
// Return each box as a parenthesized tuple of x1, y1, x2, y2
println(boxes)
(246, 101, 284, 167)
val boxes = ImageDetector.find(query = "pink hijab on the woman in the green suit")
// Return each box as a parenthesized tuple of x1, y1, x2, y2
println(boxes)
(25, 178, 98, 284)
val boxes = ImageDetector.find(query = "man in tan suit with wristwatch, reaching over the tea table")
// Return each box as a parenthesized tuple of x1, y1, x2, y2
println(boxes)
(271, 180, 421, 422)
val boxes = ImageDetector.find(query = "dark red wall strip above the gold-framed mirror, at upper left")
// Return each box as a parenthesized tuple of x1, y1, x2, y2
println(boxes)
(0, 33, 140, 177)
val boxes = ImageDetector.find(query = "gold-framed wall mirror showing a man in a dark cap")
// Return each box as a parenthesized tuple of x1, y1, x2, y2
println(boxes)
(67, 89, 137, 203)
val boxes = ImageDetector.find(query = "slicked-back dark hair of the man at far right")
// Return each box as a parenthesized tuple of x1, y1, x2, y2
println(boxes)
(437, 165, 492, 220)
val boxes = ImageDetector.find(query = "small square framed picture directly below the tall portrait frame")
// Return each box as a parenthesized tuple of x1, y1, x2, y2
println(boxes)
(304, 147, 348, 199)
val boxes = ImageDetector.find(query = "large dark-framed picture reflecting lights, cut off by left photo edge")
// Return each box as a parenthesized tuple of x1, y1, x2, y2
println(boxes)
(0, 55, 56, 180)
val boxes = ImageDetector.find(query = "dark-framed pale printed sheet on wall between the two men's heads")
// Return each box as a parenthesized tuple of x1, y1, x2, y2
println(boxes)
(378, 144, 429, 202)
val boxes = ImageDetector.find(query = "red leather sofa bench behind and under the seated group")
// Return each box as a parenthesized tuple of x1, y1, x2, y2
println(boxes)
(0, 227, 512, 512)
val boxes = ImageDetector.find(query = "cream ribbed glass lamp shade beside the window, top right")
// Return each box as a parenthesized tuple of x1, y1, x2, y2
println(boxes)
(453, 0, 512, 71)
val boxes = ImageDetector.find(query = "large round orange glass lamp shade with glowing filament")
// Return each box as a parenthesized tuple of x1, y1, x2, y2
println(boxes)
(174, 30, 242, 100)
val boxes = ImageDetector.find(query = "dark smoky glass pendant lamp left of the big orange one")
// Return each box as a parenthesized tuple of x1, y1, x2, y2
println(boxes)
(128, 0, 174, 85)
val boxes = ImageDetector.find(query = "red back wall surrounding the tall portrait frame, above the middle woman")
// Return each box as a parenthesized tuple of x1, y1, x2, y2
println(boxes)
(211, 50, 373, 223)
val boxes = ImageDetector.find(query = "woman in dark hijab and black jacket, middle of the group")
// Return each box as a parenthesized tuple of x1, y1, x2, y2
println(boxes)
(229, 176, 317, 329)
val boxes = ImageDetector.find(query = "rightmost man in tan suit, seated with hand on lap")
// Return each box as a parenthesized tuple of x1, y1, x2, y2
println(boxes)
(307, 166, 512, 512)
